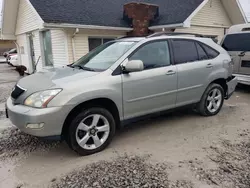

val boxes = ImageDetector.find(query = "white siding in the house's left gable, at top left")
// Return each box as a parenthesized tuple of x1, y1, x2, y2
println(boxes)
(16, 0, 43, 35)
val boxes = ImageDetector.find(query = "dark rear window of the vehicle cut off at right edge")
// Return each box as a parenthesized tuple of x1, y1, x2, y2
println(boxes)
(222, 33, 250, 51)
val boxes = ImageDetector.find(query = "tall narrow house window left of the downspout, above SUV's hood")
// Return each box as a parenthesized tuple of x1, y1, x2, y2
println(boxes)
(42, 30, 53, 66)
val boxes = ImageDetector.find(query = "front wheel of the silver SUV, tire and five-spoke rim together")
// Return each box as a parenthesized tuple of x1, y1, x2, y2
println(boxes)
(67, 107, 116, 155)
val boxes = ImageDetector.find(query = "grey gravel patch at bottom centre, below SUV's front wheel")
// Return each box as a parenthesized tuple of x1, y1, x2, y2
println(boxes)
(51, 155, 193, 188)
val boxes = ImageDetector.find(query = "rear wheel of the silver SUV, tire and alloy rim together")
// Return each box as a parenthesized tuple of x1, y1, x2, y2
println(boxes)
(197, 83, 225, 116)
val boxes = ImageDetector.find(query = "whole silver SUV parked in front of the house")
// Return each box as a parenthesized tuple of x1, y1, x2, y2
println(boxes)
(6, 33, 237, 155)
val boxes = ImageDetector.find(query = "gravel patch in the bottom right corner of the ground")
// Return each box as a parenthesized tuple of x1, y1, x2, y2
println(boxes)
(189, 130, 250, 188)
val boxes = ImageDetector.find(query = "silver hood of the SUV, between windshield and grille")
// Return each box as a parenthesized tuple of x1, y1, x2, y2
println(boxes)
(18, 67, 99, 93)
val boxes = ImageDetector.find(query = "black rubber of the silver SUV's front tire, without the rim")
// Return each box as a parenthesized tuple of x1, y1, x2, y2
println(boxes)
(66, 107, 116, 156)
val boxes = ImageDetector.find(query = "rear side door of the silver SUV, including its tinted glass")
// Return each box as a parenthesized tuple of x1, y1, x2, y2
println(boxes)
(172, 39, 218, 106)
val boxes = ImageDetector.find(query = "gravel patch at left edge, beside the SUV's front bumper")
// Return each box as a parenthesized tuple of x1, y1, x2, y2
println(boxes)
(0, 128, 59, 160)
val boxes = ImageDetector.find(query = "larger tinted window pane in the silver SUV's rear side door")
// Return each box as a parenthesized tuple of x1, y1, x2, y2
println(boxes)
(173, 40, 199, 64)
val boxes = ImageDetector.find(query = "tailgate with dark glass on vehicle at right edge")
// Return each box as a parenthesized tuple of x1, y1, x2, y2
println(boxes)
(222, 32, 250, 75)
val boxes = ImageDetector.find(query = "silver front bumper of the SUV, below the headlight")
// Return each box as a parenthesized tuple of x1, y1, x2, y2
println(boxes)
(6, 98, 70, 137)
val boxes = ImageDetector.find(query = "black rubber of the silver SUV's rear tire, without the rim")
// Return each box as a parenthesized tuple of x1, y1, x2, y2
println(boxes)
(197, 83, 225, 116)
